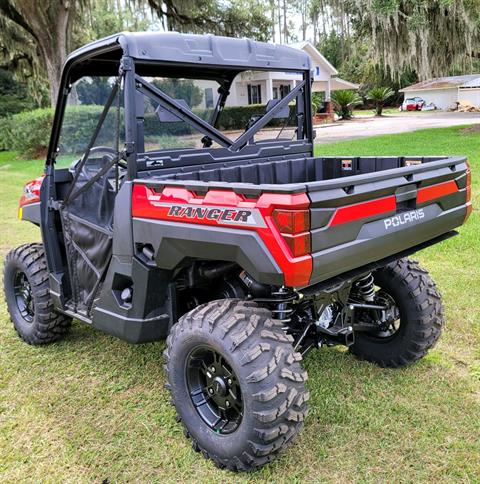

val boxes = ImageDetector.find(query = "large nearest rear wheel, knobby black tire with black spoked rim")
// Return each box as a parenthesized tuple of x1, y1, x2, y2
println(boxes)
(165, 299, 309, 471)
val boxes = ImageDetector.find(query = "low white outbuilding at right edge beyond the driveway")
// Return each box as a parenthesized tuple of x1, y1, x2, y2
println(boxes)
(400, 74, 480, 109)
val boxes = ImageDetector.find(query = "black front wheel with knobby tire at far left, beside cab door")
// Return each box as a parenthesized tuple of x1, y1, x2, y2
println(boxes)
(3, 243, 72, 345)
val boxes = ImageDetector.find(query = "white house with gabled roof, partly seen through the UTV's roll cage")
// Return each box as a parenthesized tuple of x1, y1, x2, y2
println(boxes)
(195, 42, 359, 108)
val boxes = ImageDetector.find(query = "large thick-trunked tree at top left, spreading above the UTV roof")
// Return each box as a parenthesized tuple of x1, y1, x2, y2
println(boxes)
(0, 0, 271, 105)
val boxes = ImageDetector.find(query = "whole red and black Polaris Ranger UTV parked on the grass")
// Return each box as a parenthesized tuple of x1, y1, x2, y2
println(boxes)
(4, 33, 471, 470)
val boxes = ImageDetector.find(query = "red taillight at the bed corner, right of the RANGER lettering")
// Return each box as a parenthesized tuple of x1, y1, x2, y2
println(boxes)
(272, 209, 311, 257)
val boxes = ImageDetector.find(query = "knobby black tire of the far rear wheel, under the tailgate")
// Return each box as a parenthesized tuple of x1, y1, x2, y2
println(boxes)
(350, 259, 444, 368)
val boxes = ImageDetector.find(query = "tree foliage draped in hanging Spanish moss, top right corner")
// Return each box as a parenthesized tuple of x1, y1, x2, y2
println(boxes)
(355, 0, 480, 79)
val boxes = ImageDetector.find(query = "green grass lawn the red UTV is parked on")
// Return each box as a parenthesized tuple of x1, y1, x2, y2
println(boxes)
(0, 128, 480, 483)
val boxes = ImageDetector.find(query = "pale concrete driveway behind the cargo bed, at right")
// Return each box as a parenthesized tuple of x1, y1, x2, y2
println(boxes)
(315, 112, 480, 143)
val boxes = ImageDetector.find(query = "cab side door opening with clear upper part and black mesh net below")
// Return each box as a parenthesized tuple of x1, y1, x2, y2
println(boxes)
(56, 76, 125, 317)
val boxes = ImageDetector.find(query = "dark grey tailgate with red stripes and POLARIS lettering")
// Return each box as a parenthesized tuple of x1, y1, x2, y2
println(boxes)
(308, 157, 471, 284)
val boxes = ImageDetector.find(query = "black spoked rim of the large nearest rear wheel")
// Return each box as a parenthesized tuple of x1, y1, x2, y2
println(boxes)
(186, 346, 243, 434)
